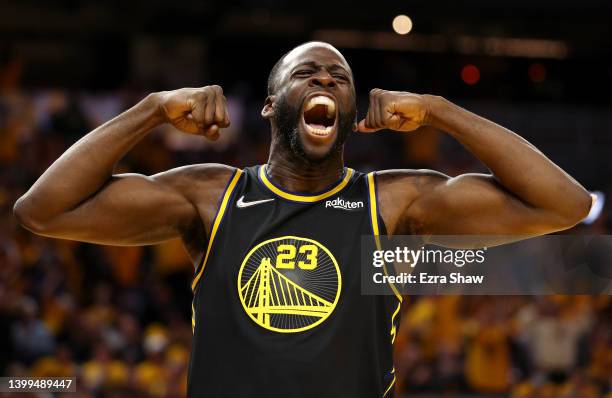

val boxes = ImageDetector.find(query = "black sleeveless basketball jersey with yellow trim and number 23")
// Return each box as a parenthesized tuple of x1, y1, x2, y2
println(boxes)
(188, 166, 401, 398)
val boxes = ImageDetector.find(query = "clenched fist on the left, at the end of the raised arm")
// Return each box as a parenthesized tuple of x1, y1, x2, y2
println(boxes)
(158, 86, 230, 141)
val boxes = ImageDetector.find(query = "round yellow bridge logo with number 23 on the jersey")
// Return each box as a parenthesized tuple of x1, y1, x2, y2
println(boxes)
(238, 236, 342, 333)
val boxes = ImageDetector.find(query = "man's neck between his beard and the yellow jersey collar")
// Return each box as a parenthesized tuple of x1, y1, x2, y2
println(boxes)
(267, 140, 344, 193)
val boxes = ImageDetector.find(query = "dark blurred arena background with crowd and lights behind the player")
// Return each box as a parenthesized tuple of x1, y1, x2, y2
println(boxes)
(0, 0, 612, 397)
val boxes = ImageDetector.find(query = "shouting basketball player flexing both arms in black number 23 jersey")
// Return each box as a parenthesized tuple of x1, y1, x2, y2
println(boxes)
(14, 42, 591, 398)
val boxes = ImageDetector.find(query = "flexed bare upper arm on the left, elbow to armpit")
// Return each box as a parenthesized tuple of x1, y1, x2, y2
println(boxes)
(41, 174, 196, 245)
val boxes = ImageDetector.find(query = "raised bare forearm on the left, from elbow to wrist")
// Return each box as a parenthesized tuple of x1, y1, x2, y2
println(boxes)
(15, 94, 162, 223)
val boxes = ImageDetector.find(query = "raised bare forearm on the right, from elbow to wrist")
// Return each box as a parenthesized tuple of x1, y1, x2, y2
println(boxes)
(427, 96, 591, 222)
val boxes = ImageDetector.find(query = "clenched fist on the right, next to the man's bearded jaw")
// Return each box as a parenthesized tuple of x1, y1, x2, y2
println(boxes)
(357, 88, 428, 133)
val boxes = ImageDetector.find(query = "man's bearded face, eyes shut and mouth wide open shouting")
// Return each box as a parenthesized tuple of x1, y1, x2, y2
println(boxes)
(273, 43, 356, 162)
